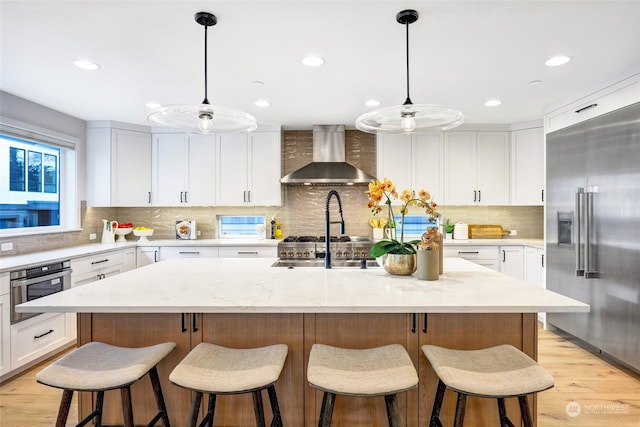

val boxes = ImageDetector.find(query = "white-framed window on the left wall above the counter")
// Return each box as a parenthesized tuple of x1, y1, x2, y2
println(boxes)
(0, 124, 78, 236)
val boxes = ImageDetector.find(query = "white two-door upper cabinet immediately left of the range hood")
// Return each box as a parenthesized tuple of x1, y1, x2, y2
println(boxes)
(215, 131, 282, 206)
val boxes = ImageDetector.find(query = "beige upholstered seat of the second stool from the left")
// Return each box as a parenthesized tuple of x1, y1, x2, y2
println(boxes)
(169, 343, 288, 394)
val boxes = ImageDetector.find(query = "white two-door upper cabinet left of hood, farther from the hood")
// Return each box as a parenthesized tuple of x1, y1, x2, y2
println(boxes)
(153, 133, 216, 206)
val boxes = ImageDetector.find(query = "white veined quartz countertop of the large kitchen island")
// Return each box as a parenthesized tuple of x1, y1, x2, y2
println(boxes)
(18, 258, 589, 313)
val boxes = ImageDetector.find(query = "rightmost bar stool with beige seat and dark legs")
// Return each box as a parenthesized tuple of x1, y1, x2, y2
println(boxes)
(422, 345, 553, 427)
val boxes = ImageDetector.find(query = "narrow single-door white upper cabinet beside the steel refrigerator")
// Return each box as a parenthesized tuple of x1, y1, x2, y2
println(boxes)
(511, 127, 544, 206)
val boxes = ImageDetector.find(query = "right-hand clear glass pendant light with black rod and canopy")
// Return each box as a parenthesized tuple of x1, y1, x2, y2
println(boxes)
(356, 9, 464, 134)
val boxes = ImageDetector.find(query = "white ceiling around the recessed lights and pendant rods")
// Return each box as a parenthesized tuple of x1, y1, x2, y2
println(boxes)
(0, 0, 640, 129)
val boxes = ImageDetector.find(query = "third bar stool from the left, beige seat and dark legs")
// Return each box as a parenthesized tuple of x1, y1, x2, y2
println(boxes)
(307, 344, 418, 427)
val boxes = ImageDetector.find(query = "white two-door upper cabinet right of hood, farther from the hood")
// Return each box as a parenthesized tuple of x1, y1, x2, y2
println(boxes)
(444, 131, 509, 205)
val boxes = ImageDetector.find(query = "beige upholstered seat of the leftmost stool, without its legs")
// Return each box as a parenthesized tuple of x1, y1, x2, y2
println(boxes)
(36, 342, 176, 391)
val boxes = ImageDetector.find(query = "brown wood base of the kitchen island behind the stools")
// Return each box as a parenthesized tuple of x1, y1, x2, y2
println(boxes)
(78, 313, 538, 427)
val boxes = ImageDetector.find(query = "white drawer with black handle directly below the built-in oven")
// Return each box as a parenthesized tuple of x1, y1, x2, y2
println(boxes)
(11, 313, 67, 370)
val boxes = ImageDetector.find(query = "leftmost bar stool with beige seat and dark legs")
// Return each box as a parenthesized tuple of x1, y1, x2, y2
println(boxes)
(36, 342, 176, 427)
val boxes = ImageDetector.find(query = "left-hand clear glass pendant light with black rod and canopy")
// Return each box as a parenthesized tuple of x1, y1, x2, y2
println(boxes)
(147, 12, 258, 133)
